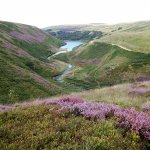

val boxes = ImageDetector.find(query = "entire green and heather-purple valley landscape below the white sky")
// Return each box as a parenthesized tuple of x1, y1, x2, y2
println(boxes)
(0, 21, 150, 150)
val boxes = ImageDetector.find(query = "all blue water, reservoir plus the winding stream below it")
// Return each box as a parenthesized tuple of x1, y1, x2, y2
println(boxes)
(55, 41, 82, 82)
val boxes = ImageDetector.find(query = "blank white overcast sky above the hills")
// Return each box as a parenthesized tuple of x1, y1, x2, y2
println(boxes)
(0, 0, 150, 28)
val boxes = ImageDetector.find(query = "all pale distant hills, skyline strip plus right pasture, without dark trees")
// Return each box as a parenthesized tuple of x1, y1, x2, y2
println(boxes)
(45, 21, 150, 53)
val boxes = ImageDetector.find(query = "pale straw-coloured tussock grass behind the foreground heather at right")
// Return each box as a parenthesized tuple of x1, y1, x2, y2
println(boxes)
(68, 81, 150, 109)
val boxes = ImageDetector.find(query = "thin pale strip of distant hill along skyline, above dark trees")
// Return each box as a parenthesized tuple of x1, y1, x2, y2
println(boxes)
(43, 21, 150, 33)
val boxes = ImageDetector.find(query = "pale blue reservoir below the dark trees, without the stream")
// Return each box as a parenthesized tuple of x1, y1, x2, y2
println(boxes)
(61, 41, 82, 52)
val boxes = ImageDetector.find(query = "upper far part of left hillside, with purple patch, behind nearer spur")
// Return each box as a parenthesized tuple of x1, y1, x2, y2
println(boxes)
(0, 22, 63, 60)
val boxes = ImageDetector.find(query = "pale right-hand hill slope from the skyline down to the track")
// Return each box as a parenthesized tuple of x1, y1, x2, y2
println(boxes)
(100, 21, 150, 53)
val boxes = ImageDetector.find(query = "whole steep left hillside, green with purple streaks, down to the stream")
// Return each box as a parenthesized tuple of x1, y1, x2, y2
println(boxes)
(0, 22, 68, 103)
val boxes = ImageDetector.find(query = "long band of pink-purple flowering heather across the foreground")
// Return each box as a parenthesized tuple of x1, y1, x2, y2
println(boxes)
(0, 97, 150, 140)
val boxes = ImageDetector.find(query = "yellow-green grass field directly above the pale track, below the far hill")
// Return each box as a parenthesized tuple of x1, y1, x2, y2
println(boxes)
(98, 31, 150, 53)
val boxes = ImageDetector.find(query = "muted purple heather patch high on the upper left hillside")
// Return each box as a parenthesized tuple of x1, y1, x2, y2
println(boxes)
(10, 31, 46, 43)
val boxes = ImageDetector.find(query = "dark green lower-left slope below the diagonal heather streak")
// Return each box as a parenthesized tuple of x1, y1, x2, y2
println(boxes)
(0, 59, 62, 104)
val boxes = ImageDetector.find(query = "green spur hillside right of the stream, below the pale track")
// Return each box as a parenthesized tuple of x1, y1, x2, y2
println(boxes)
(56, 41, 150, 89)
